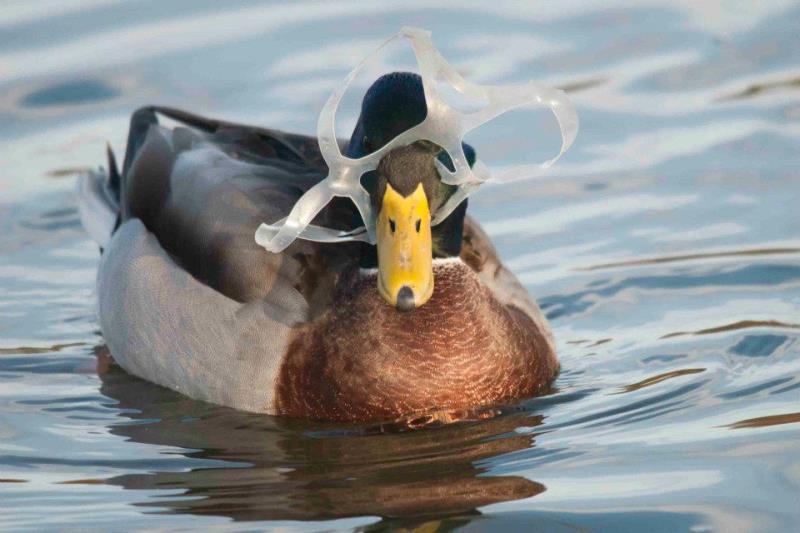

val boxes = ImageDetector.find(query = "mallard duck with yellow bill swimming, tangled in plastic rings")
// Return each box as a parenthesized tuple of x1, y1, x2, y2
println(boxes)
(78, 72, 559, 422)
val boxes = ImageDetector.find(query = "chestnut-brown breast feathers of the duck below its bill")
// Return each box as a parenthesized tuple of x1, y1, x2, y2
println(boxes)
(276, 262, 558, 421)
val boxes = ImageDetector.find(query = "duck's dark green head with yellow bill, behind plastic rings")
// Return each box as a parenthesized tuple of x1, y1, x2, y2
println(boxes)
(347, 72, 475, 311)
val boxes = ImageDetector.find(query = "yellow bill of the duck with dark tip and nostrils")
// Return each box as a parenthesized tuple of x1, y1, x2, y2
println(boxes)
(377, 183, 433, 311)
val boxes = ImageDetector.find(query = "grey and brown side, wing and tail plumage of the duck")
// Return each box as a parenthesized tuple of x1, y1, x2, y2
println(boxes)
(78, 115, 319, 413)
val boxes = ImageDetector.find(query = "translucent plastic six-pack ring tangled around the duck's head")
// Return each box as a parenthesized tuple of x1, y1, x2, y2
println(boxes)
(255, 27, 578, 253)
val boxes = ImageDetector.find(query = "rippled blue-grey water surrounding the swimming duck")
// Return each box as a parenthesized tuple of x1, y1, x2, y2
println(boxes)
(0, 0, 800, 531)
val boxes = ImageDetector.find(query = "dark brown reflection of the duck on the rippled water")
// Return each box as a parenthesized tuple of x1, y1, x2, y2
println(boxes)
(94, 356, 544, 520)
